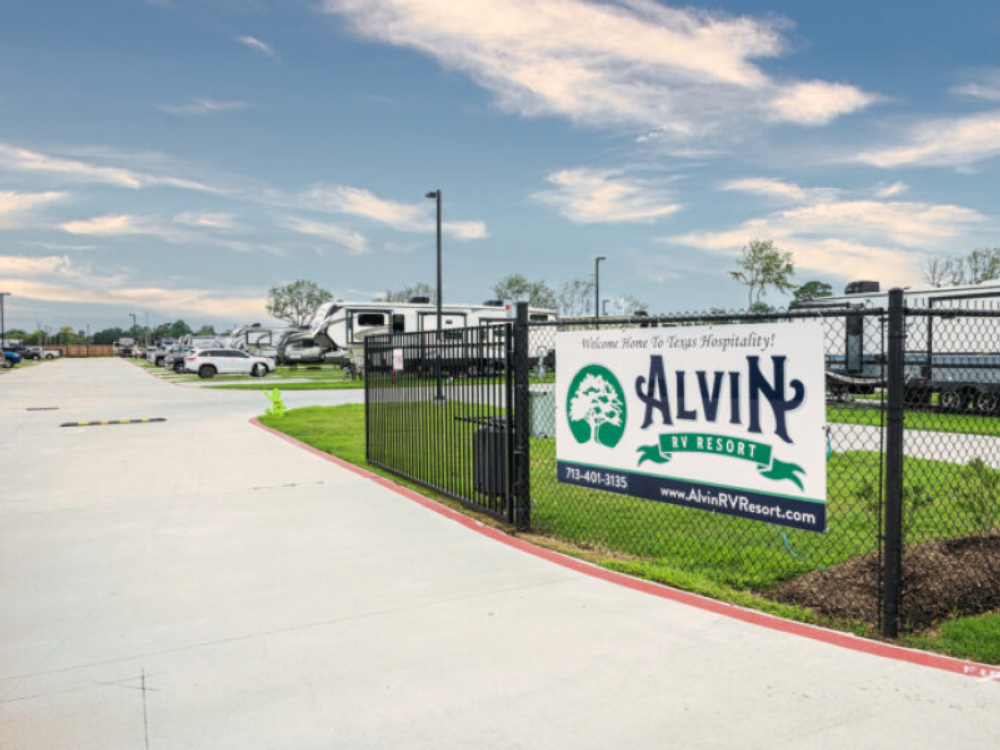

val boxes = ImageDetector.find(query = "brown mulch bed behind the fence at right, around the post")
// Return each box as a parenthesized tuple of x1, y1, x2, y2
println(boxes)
(773, 532, 1000, 631)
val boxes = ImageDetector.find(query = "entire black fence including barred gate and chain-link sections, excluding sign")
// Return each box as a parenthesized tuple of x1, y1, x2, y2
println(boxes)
(366, 292, 1000, 636)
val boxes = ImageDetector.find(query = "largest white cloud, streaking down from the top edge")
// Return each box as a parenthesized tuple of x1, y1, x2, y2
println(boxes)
(322, 0, 876, 141)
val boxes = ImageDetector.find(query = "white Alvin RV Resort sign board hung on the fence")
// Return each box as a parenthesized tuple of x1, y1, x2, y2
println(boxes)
(556, 321, 827, 531)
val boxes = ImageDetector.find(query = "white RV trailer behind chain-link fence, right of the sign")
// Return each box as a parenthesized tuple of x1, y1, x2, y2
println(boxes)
(797, 281, 1000, 414)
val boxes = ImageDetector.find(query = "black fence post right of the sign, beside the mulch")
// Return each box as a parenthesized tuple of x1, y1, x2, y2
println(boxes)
(882, 289, 906, 638)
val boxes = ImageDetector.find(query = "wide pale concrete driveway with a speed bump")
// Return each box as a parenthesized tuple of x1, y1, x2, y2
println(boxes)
(0, 360, 1000, 750)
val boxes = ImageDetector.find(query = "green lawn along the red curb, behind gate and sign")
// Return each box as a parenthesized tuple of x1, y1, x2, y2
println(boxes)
(261, 402, 1000, 663)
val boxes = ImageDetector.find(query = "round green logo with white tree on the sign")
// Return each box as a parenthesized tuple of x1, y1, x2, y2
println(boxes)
(566, 365, 626, 448)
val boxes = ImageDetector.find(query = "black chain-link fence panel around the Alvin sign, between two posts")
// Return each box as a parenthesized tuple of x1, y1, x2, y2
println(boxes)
(528, 310, 886, 626)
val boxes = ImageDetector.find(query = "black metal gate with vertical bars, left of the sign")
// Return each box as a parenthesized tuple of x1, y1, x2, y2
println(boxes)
(365, 323, 516, 523)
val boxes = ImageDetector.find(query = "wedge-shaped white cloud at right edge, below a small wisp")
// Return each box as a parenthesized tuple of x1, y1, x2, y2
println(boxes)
(854, 110, 1000, 169)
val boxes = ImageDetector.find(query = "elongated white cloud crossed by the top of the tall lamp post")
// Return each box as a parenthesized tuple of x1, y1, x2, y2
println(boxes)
(286, 185, 488, 240)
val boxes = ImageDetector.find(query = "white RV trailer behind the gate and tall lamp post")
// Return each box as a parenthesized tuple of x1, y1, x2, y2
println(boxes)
(281, 297, 556, 367)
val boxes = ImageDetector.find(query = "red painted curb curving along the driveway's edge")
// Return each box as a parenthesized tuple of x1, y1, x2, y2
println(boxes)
(250, 417, 1000, 682)
